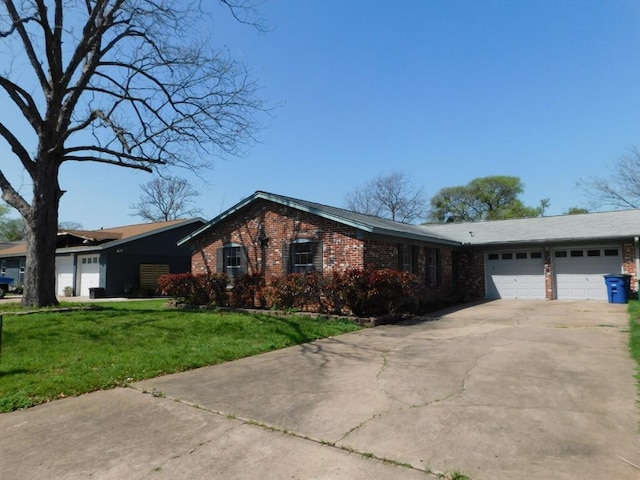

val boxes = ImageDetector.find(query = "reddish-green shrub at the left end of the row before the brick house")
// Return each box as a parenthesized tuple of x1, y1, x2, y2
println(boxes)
(158, 273, 227, 306)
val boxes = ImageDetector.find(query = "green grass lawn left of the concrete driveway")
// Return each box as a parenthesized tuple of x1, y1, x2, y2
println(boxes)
(0, 301, 360, 412)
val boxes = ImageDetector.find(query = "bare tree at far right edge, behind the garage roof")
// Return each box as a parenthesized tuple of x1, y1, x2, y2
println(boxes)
(577, 148, 640, 210)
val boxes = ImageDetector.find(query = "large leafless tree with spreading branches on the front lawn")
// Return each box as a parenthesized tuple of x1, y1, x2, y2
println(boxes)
(0, 0, 263, 306)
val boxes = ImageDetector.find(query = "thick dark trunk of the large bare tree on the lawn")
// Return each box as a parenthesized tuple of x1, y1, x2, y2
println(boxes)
(22, 159, 62, 307)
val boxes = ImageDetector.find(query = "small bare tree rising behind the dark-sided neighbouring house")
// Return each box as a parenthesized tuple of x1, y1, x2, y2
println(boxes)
(131, 177, 202, 222)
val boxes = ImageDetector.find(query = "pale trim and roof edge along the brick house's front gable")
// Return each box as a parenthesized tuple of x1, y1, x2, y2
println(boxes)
(177, 191, 461, 246)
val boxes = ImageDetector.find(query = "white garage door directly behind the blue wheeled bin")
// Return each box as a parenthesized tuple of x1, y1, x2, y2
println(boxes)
(552, 247, 622, 300)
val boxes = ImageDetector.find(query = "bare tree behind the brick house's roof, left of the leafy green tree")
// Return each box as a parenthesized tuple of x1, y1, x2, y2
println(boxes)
(345, 172, 427, 223)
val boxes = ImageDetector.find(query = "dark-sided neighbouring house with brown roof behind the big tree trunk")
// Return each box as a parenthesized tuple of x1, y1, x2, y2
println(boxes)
(0, 218, 204, 296)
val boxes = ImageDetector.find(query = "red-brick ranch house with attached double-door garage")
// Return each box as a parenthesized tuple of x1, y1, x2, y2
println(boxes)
(178, 192, 640, 300)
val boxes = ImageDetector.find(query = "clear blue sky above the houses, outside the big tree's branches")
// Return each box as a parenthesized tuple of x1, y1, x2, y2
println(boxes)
(0, 0, 640, 228)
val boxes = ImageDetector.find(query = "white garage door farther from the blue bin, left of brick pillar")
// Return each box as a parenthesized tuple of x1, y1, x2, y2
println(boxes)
(486, 251, 545, 299)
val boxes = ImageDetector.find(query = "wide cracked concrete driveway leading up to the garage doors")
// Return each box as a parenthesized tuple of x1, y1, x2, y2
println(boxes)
(0, 301, 640, 480)
